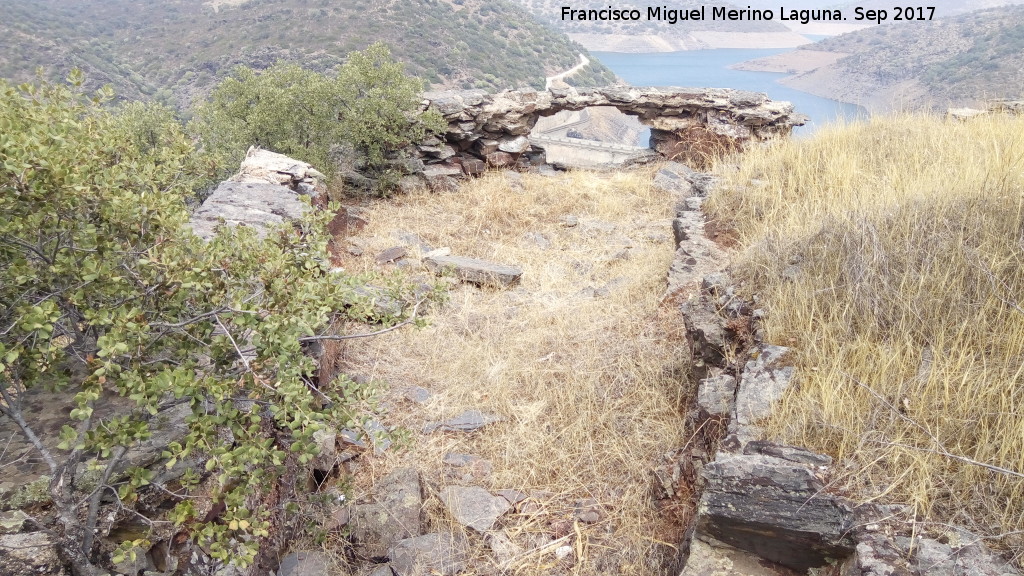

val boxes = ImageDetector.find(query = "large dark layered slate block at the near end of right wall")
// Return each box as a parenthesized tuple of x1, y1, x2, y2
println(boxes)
(697, 454, 856, 571)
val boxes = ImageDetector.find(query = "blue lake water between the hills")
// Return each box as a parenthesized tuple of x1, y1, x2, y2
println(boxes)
(592, 48, 866, 138)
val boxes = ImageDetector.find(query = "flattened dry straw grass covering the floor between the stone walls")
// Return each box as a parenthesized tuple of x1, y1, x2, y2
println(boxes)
(331, 165, 689, 575)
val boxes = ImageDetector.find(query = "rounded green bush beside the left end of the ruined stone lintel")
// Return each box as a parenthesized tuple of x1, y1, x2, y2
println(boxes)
(194, 43, 444, 189)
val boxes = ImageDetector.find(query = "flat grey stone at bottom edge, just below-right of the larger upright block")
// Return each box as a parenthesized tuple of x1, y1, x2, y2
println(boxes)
(388, 532, 469, 576)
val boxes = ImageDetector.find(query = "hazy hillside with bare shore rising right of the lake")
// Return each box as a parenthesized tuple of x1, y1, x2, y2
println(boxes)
(742, 5, 1024, 111)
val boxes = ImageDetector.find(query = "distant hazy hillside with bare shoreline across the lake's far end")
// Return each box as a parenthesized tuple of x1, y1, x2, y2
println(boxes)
(516, 0, 807, 52)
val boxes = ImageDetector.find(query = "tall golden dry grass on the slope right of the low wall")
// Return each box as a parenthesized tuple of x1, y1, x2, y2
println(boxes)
(706, 116, 1024, 560)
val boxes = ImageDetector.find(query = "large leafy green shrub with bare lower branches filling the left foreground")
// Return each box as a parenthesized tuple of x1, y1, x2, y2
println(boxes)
(0, 73, 411, 575)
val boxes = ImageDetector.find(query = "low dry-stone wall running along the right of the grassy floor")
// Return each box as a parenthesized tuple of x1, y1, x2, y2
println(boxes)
(667, 164, 1018, 576)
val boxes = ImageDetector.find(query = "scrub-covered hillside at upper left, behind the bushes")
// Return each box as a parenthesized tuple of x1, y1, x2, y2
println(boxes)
(0, 0, 614, 106)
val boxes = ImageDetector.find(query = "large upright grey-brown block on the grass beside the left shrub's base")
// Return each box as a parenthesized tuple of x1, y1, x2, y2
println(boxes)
(349, 467, 423, 558)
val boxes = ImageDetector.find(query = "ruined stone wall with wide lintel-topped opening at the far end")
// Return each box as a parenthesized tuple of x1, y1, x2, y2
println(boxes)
(409, 86, 807, 186)
